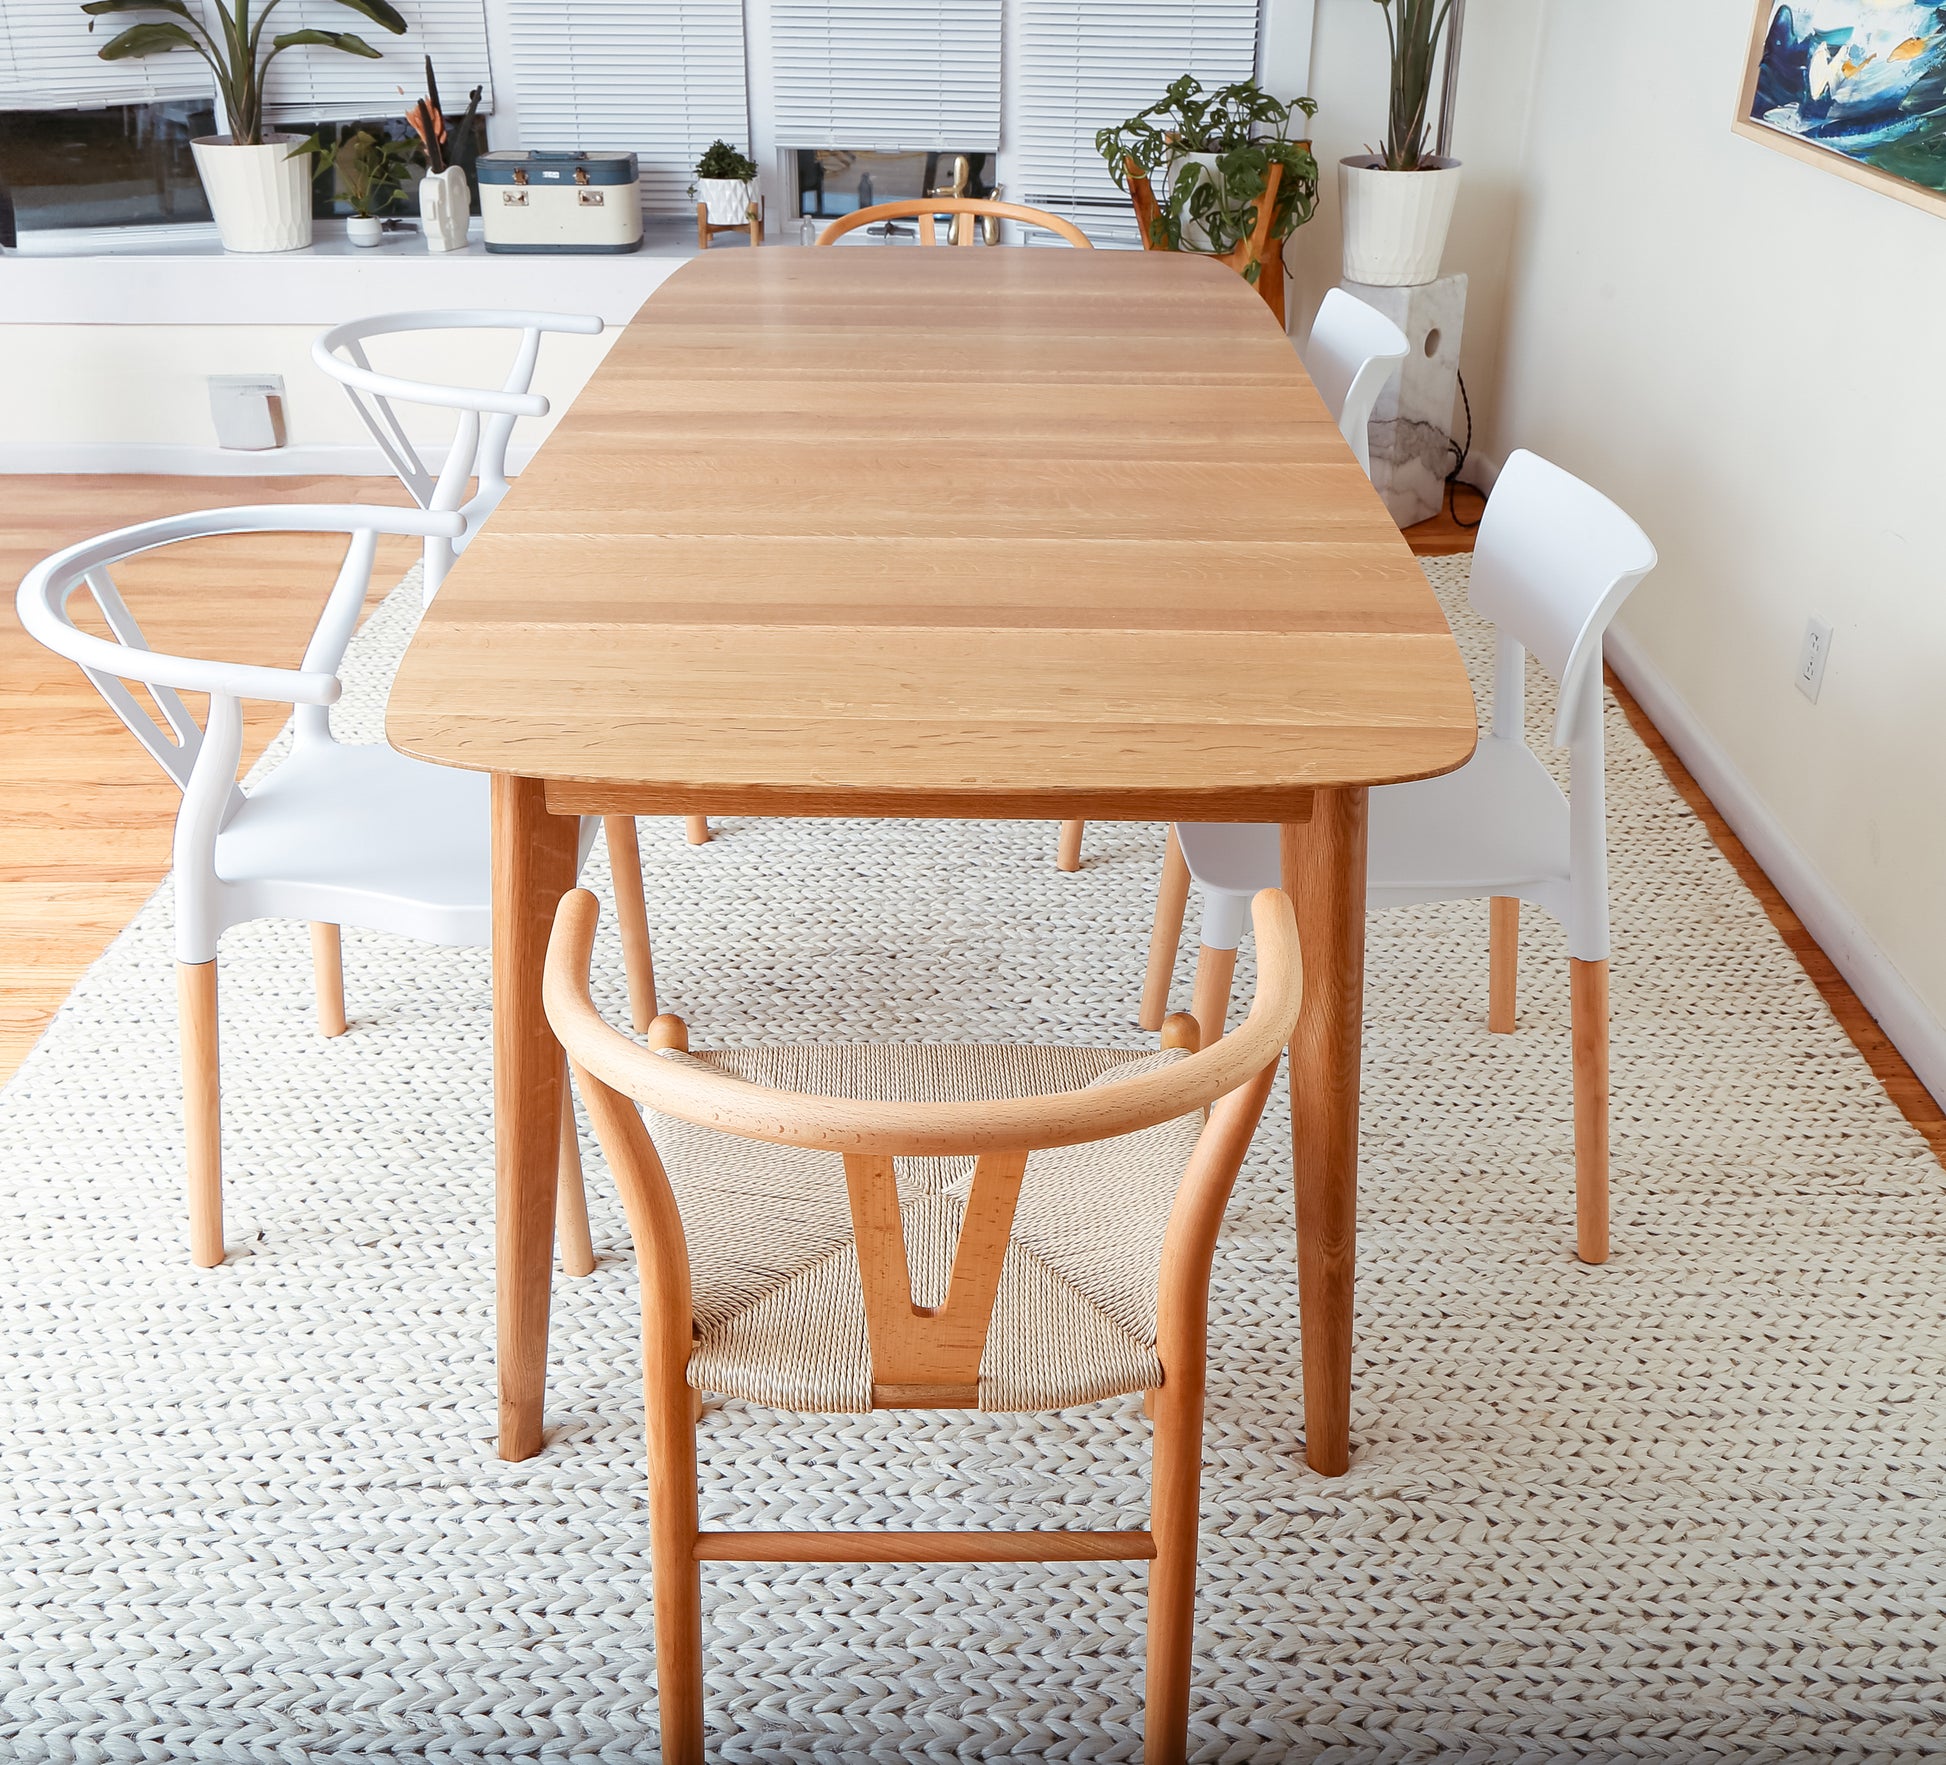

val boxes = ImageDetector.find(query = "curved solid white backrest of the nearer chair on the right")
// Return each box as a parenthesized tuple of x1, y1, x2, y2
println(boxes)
(1467, 448, 1656, 747)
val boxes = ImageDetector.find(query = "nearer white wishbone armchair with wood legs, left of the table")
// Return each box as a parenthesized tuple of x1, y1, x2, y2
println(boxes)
(18, 506, 656, 1275)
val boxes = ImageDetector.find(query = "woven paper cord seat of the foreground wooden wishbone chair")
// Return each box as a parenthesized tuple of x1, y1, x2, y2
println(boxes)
(646, 1043, 1203, 1411)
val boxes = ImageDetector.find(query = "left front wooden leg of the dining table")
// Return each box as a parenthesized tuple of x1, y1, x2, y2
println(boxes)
(492, 773, 580, 1459)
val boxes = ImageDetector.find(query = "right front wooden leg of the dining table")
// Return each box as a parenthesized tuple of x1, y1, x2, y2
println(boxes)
(1282, 790, 1366, 1477)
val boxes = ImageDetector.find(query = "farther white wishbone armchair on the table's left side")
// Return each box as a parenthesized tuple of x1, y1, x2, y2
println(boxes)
(311, 307, 710, 864)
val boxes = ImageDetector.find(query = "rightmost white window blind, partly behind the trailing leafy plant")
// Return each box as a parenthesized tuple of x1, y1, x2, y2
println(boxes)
(1004, 0, 1257, 245)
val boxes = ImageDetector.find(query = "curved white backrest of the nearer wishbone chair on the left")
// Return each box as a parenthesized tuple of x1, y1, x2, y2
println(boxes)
(16, 504, 461, 919)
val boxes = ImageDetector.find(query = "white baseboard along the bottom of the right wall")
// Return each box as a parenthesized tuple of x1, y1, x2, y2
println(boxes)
(1605, 627, 1946, 1103)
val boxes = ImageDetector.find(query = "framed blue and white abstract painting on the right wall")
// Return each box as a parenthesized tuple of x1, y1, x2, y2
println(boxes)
(1734, 0, 1946, 214)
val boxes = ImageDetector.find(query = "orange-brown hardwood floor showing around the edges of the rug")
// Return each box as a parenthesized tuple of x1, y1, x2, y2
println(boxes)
(0, 477, 1946, 1160)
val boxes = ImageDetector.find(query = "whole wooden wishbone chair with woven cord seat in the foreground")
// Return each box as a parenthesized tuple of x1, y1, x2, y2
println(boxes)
(545, 891, 1302, 1765)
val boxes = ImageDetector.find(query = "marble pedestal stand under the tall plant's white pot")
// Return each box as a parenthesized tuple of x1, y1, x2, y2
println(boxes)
(1341, 276, 1465, 527)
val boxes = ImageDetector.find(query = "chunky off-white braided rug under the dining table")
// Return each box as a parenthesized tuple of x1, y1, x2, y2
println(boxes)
(0, 560, 1946, 1761)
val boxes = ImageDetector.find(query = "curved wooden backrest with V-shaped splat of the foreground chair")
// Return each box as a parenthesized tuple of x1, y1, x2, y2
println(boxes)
(545, 889, 1304, 1401)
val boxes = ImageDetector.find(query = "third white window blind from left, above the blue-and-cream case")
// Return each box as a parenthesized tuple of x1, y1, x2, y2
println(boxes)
(505, 0, 749, 214)
